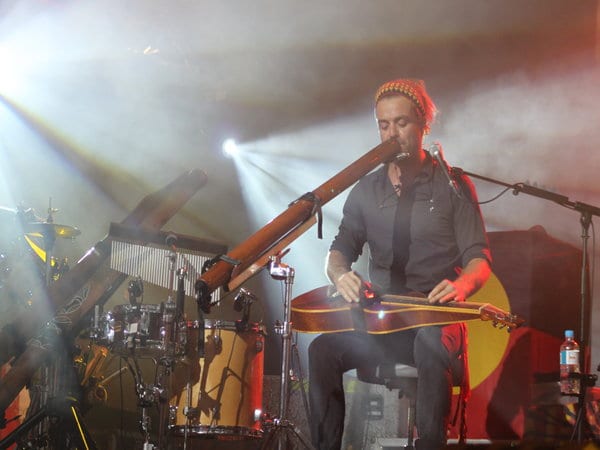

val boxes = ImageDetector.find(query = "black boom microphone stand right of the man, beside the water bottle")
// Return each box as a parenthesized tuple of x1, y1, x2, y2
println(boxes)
(451, 167, 600, 443)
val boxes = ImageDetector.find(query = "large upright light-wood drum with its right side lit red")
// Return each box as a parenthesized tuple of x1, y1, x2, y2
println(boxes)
(169, 320, 264, 440)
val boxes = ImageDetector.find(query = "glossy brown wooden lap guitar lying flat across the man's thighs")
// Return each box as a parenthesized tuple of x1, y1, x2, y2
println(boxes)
(291, 286, 525, 334)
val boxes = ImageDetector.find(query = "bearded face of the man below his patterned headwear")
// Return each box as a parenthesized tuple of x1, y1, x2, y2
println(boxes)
(375, 95, 423, 157)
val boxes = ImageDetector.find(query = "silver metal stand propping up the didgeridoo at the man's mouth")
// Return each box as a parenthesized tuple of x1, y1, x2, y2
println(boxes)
(260, 257, 314, 450)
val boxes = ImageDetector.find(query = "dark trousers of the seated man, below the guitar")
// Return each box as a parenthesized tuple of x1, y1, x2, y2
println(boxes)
(308, 323, 464, 450)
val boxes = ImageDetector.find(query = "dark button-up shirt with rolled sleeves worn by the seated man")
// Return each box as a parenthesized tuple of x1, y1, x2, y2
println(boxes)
(330, 149, 491, 293)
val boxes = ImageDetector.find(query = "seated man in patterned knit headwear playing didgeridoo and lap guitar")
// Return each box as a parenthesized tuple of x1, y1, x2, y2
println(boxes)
(309, 79, 491, 450)
